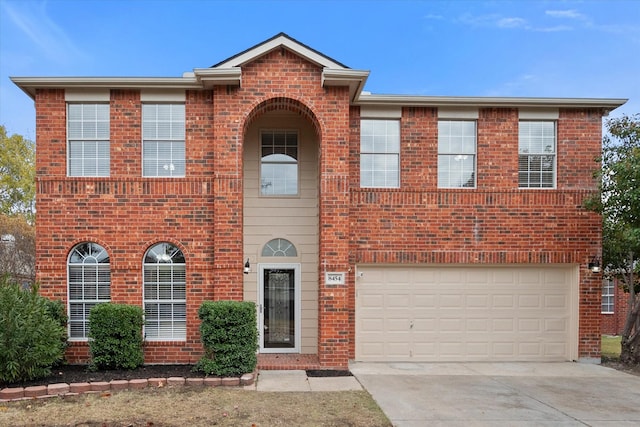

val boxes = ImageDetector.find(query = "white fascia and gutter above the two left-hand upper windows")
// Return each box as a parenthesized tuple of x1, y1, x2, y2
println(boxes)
(11, 76, 202, 99)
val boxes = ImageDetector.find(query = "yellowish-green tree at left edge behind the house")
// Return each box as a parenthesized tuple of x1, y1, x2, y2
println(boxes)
(0, 126, 36, 223)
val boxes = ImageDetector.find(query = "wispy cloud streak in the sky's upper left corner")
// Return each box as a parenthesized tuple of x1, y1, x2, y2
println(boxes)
(0, 1, 86, 63)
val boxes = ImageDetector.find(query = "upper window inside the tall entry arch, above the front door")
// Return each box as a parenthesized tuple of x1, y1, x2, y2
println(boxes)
(260, 130, 299, 196)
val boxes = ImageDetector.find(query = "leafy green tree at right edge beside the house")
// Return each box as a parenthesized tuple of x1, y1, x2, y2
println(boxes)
(586, 114, 640, 364)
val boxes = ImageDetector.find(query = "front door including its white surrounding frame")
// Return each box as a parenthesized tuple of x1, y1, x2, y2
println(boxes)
(259, 264, 300, 353)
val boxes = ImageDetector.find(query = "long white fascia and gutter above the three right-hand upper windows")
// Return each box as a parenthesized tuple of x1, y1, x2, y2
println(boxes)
(355, 93, 628, 110)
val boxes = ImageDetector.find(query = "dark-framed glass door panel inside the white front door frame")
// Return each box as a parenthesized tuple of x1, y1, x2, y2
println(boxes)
(263, 269, 295, 348)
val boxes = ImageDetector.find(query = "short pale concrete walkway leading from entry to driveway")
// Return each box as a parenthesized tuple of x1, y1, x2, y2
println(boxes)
(255, 371, 362, 392)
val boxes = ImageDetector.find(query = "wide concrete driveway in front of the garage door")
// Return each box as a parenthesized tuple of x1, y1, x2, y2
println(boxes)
(349, 362, 640, 427)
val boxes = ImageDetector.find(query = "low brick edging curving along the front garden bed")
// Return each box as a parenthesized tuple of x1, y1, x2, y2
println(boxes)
(0, 372, 257, 402)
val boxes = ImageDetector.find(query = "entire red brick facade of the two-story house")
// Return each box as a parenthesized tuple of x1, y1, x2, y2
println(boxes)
(36, 49, 601, 367)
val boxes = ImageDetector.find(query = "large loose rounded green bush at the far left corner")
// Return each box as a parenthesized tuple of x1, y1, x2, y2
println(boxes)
(0, 276, 66, 383)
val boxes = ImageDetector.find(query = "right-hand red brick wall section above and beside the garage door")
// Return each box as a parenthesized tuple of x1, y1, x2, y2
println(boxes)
(349, 108, 601, 358)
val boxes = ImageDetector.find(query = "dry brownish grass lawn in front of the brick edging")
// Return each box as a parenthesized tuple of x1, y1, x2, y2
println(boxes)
(0, 387, 391, 427)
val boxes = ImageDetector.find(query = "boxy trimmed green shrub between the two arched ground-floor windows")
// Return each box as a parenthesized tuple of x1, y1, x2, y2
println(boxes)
(89, 303, 144, 370)
